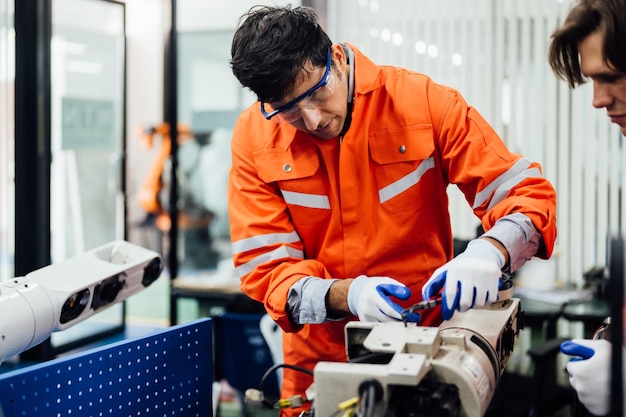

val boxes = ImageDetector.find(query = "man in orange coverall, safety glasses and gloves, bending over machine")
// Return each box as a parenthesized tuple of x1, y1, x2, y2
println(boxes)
(228, 6, 556, 416)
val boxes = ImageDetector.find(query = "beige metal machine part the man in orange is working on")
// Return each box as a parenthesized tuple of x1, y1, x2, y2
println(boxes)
(312, 298, 523, 417)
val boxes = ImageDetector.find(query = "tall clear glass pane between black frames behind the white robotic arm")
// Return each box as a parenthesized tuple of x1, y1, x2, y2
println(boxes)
(50, 0, 125, 345)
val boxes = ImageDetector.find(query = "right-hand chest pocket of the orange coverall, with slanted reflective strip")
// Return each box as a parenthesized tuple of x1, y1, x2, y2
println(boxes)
(369, 125, 435, 213)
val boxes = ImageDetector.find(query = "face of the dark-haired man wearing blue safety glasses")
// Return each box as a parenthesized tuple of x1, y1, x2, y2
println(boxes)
(270, 44, 348, 139)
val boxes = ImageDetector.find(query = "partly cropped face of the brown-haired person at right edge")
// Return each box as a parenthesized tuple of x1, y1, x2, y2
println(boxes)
(578, 31, 626, 136)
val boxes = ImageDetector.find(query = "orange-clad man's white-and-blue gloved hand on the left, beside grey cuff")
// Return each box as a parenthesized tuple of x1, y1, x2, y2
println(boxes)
(348, 275, 420, 323)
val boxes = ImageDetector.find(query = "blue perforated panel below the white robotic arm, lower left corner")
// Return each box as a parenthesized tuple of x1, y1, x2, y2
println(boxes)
(0, 319, 213, 417)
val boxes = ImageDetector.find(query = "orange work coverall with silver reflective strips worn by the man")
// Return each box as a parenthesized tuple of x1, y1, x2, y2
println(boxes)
(228, 46, 556, 416)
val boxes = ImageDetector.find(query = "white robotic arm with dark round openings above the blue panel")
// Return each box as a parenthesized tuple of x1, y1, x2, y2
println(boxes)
(0, 240, 163, 364)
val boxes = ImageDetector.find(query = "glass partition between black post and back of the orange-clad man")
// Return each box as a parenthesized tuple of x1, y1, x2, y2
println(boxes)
(163, 0, 300, 323)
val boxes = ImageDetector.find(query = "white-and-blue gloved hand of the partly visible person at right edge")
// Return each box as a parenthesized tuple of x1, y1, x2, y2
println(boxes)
(561, 339, 611, 416)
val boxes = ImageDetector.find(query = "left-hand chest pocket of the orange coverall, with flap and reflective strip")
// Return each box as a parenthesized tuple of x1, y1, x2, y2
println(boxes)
(254, 143, 330, 225)
